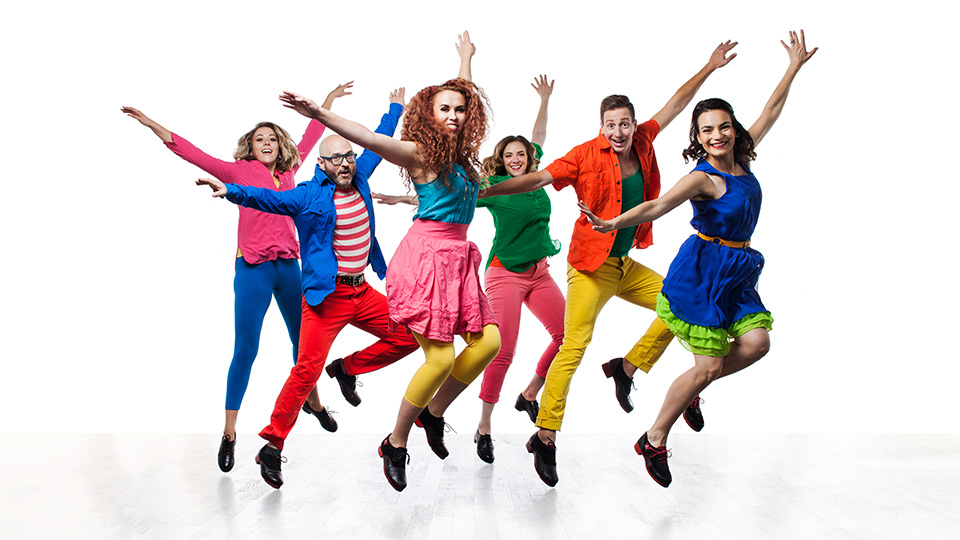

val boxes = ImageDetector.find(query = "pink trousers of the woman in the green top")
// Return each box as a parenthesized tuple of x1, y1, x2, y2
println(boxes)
(480, 258, 564, 403)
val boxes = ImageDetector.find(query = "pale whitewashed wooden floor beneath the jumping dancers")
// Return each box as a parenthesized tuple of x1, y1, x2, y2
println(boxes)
(0, 429, 960, 540)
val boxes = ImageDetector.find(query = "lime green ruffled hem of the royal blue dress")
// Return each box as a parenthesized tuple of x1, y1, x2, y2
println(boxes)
(657, 293, 773, 356)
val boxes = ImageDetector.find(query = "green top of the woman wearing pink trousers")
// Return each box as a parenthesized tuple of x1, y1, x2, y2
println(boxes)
(477, 143, 564, 272)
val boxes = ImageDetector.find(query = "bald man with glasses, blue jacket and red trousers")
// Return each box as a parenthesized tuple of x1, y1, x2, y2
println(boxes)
(197, 88, 418, 488)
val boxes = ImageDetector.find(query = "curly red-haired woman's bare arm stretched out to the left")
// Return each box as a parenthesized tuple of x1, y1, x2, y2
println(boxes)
(280, 92, 419, 169)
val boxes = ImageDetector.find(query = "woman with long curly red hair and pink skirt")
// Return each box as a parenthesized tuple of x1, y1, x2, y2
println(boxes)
(280, 32, 500, 491)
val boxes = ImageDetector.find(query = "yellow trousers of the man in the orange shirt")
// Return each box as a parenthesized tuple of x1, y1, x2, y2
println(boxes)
(537, 257, 673, 431)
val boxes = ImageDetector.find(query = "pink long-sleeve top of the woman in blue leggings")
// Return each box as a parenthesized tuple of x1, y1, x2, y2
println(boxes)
(164, 120, 325, 264)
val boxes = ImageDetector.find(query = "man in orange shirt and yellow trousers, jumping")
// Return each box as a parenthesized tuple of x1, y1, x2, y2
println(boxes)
(482, 41, 737, 486)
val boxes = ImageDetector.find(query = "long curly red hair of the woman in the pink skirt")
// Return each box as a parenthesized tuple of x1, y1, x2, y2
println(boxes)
(400, 78, 489, 186)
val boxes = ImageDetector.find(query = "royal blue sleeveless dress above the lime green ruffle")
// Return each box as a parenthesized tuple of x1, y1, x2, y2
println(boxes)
(661, 161, 773, 336)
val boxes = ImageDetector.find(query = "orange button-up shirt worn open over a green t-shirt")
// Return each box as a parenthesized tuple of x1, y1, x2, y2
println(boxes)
(546, 120, 660, 272)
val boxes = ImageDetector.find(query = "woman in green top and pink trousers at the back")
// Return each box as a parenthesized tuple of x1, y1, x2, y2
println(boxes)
(373, 75, 565, 463)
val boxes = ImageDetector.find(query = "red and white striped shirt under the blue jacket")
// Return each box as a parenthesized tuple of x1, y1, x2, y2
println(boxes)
(333, 189, 371, 276)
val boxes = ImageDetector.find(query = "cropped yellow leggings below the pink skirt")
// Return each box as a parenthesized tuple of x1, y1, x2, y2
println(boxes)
(403, 324, 500, 409)
